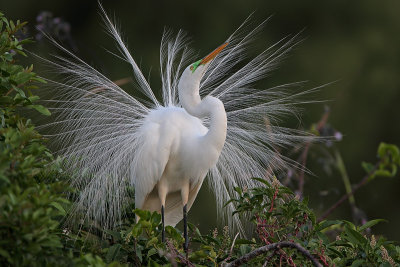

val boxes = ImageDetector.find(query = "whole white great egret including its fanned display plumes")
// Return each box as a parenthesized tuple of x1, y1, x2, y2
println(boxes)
(42, 5, 312, 248)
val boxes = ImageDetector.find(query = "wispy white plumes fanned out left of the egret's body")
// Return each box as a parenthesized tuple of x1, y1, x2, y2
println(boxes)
(39, 8, 159, 228)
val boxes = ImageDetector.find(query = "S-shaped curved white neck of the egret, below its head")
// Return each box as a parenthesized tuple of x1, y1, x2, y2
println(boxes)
(179, 79, 227, 152)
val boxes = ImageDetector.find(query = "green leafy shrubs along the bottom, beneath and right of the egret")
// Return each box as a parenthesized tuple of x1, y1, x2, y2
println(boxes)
(68, 181, 400, 266)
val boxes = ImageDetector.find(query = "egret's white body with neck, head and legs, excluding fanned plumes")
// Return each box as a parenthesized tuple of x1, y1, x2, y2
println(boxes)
(135, 59, 227, 247)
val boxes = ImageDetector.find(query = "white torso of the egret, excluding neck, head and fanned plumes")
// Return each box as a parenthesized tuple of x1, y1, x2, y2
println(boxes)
(135, 103, 226, 226)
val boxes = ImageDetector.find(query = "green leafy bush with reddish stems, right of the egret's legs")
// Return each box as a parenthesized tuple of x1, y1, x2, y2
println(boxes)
(223, 179, 400, 266)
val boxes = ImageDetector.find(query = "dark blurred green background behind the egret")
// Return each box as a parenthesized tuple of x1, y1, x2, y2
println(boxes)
(0, 0, 400, 241)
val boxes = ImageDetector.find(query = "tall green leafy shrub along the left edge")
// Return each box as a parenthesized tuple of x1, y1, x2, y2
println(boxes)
(0, 13, 117, 266)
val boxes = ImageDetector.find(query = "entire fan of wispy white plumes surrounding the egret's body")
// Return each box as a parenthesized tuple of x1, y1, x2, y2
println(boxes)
(37, 7, 314, 233)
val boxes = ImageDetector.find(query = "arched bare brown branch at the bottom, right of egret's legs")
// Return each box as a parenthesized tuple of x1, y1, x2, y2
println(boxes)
(225, 241, 322, 267)
